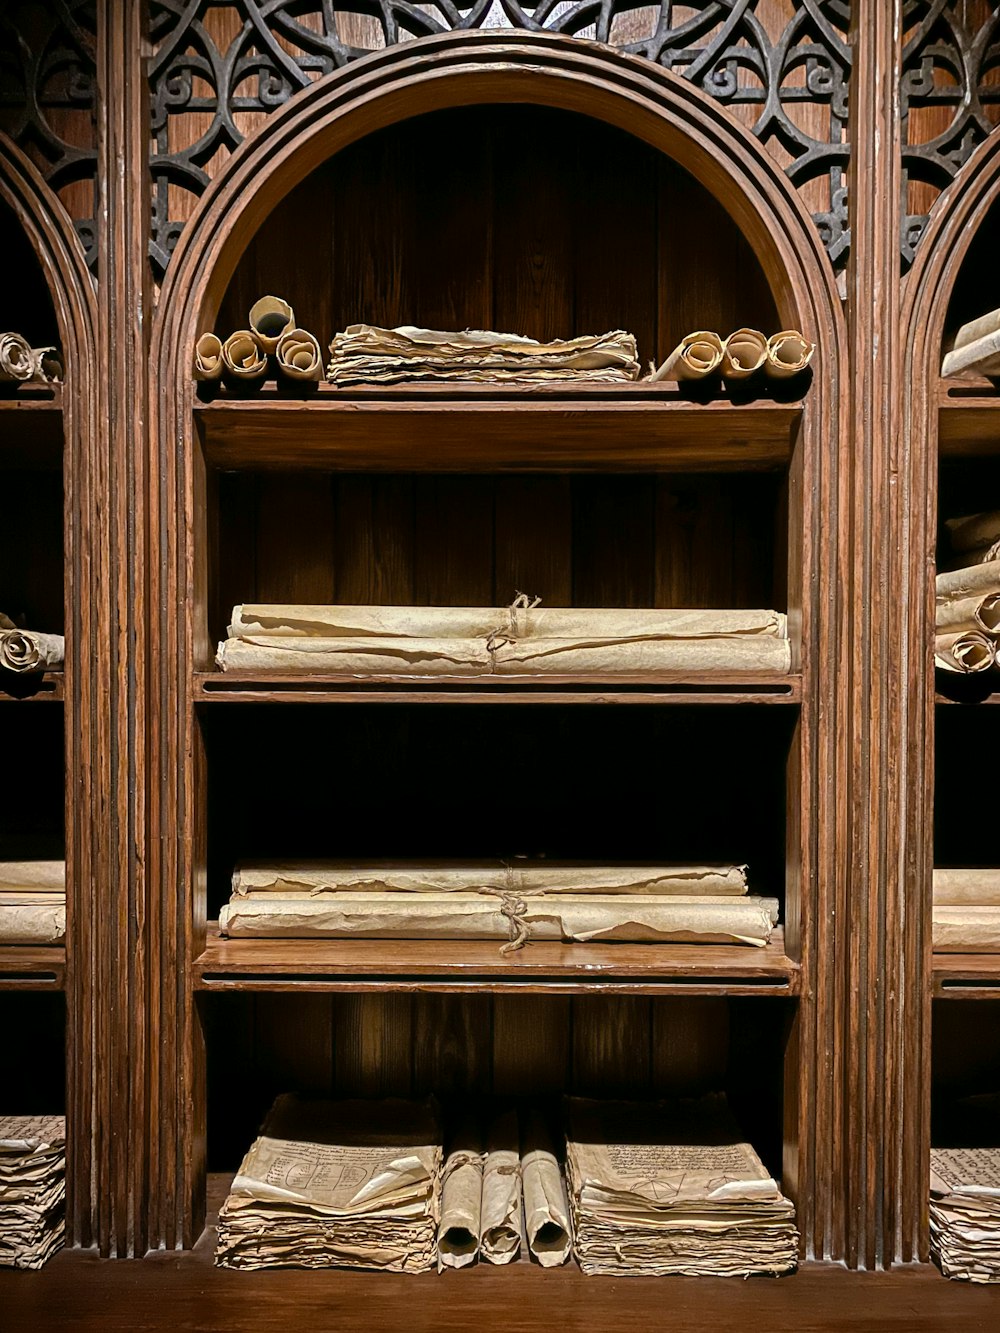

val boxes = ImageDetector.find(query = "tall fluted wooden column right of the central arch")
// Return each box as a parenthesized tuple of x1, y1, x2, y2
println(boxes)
(840, 0, 925, 1268)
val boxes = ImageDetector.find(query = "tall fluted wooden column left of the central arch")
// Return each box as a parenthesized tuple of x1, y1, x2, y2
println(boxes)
(91, 0, 152, 1256)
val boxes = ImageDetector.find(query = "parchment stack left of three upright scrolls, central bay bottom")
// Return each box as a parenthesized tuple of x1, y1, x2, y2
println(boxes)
(216, 1096, 441, 1273)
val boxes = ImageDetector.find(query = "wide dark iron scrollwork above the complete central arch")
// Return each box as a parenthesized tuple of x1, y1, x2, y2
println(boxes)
(149, 0, 851, 273)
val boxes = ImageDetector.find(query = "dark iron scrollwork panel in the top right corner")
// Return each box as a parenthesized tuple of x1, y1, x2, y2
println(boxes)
(900, 0, 1000, 265)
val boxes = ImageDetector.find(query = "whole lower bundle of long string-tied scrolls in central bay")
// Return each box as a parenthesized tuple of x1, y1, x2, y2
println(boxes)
(219, 860, 777, 953)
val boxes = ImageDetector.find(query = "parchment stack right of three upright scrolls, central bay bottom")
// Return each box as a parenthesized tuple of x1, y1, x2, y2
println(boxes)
(567, 1094, 799, 1277)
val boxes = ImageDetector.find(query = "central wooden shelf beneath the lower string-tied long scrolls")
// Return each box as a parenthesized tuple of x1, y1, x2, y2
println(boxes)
(192, 922, 799, 996)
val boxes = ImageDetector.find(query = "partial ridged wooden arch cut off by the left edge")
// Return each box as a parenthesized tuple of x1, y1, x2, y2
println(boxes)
(0, 133, 109, 1245)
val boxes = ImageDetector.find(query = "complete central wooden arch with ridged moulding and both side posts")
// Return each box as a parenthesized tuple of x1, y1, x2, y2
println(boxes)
(147, 31, 847, 1256)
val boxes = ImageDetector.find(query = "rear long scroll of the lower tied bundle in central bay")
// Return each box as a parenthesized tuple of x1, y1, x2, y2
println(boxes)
(234, 858, 747, 898)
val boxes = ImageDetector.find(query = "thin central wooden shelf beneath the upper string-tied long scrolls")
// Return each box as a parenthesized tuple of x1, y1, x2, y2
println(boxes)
(195, 672, 803, 704)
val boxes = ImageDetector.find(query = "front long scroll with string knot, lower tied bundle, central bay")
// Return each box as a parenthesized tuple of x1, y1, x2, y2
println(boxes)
(219, 892, 777, 952)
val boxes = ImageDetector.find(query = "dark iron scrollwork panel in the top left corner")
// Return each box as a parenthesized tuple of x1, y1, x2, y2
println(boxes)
(0, 0, 97, 269)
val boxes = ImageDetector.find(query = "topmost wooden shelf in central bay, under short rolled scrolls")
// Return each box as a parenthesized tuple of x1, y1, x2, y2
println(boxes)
(195, 384, 801, 472)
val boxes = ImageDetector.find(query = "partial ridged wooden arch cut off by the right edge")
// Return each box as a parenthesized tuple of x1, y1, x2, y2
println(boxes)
(899, 132, 1000, 1258)
